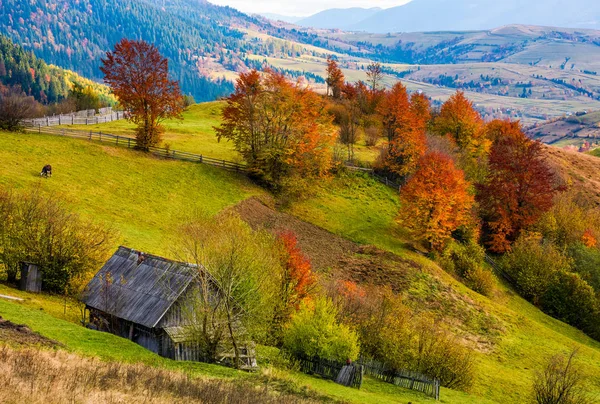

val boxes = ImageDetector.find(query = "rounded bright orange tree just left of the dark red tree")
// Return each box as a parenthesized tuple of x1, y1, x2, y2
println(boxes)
(399, 152, 474, 250)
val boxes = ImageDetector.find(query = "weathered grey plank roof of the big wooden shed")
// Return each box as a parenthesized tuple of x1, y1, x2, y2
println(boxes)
(83, 247, 195, 328)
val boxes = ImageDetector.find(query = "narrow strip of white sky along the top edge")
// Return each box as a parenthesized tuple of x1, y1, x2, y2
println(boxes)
(208, 0, 410, 17)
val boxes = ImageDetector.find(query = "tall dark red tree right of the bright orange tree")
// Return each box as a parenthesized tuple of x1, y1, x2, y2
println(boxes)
(477, 122, 558, 253)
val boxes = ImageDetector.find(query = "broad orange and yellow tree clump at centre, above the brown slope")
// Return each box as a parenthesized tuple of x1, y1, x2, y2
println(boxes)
(215, 70, 336, 191)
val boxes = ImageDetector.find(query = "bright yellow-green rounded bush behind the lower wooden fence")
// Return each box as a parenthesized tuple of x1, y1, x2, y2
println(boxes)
(283, 298, 359, 361)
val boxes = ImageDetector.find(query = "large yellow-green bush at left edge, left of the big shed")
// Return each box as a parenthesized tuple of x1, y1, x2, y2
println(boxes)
(0, 186, 114, 293)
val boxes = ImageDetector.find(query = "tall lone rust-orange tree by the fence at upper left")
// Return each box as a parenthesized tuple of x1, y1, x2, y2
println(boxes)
(100, 38, 183, 150)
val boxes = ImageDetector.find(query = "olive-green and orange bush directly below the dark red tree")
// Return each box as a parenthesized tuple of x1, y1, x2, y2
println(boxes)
(501, 234, 571, 304)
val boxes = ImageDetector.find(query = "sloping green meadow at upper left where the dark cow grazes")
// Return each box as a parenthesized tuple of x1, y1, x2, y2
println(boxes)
(0, 132, 263, 255)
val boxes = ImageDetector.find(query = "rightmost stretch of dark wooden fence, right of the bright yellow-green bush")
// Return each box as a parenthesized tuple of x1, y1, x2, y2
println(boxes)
(357, 358, 440, 400)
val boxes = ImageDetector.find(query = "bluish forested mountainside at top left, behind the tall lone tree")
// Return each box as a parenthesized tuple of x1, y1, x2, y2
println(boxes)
(0, 0, 254, 100)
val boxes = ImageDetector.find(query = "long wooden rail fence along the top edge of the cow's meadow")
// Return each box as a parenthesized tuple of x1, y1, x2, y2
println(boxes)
(26, 126, 247, 172)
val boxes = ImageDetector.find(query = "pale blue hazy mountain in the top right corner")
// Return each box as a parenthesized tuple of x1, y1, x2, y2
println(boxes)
(346, 0, 600, 33)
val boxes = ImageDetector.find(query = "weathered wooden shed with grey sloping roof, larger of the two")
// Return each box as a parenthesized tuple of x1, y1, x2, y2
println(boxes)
(82, 247, 255, 364)
